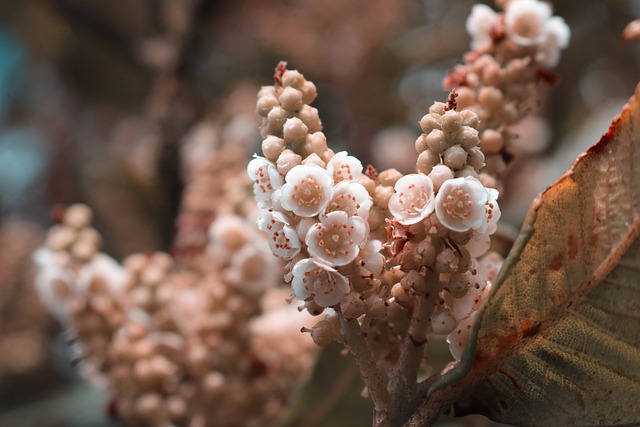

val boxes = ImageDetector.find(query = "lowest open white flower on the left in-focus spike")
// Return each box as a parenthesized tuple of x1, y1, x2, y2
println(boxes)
(291, 258, 350, 307)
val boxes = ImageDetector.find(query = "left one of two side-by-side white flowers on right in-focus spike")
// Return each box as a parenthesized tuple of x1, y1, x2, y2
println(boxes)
(389, 173, 434, 225)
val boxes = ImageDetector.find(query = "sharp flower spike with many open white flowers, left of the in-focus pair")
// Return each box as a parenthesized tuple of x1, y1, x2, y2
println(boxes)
(252, 64, 384, 314)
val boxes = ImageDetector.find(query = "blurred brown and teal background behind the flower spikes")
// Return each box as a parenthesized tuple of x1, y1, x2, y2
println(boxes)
(0, 0, 640, 427)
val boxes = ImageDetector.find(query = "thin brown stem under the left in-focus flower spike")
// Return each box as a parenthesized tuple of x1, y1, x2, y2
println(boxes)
(338, 313, 390, 427)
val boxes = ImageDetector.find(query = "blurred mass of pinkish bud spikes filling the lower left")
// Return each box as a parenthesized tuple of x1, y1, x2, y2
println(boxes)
(35, 108, 315, 427)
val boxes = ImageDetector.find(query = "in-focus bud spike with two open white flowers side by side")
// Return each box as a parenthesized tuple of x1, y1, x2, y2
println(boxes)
(387, 92, 500, 359)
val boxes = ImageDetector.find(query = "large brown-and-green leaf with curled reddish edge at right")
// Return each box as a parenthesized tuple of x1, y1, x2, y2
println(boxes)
(427, 86, 640, 426)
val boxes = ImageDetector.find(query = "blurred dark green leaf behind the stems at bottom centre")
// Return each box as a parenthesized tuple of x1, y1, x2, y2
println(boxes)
(277, 343, 373, 427)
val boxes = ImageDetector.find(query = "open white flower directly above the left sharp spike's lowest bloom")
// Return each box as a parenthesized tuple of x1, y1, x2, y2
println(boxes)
(305, 211, 367, 266)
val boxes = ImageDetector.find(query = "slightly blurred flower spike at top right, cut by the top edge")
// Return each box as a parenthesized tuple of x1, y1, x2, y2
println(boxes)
(444, 0, 570, 182)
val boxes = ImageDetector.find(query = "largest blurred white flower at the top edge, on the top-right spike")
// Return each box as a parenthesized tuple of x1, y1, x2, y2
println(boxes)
(504, 0, 551, 46)
